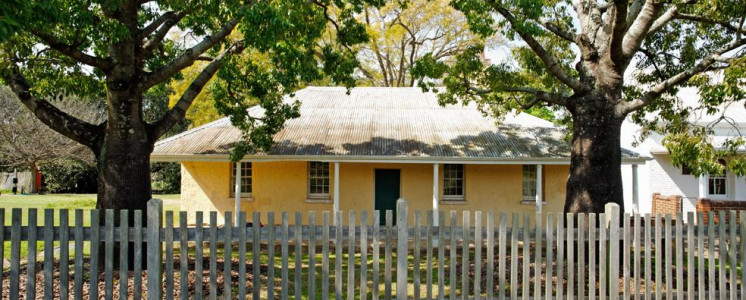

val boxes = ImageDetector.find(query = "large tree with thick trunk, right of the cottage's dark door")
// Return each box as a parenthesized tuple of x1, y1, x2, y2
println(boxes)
(413, 0, 746, 212)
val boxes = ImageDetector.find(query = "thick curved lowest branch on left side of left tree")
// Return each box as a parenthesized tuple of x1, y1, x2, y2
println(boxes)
(0, 65, 103, 151)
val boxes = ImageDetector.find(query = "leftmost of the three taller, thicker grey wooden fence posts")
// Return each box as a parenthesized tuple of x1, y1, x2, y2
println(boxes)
(146, 199, 163, 300)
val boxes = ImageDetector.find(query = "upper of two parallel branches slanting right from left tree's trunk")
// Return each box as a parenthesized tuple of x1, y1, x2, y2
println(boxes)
(140, 19, 238, 90)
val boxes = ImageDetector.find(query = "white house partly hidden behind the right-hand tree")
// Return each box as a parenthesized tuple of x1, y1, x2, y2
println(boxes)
(621, 89, 746, 215)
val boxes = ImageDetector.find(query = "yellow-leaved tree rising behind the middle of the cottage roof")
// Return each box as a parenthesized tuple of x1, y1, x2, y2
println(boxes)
(358, 0, 480, 87)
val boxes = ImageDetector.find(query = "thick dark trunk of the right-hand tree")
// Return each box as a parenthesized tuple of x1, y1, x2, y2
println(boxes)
(565, 96, 624, 213)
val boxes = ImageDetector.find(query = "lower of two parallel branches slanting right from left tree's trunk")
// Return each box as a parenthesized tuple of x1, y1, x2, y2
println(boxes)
(148, 43, 245, 141)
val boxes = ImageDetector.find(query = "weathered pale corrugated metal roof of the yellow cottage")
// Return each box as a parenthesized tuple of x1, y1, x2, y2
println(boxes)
(152, 87, 640, 161)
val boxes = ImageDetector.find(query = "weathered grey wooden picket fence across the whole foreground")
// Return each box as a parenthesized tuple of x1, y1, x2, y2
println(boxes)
(0, 200, 746, 300)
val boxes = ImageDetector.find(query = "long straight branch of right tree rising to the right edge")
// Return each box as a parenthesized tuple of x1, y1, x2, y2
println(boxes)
(623, 40, 746, 113)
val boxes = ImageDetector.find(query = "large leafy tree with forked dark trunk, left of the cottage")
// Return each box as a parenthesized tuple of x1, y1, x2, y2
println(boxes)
(0, 0, 380, 209)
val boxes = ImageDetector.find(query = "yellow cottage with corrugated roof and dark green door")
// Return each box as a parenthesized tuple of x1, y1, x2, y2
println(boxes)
(151, 87, 644, 222)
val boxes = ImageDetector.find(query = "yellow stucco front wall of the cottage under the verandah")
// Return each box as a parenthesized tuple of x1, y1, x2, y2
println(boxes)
(181, 162, 568, 224)
